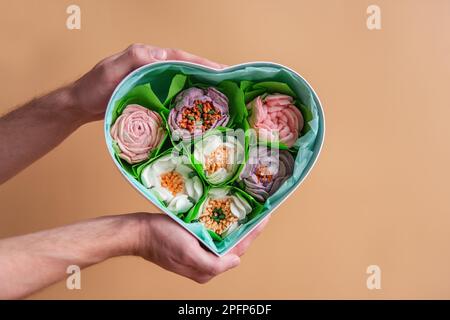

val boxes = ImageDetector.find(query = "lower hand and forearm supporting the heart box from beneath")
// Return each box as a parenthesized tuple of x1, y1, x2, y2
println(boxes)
(0, 213, 267, 299)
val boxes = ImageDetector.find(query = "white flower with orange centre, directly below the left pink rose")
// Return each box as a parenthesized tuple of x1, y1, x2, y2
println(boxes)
(141, 154, 203, 213)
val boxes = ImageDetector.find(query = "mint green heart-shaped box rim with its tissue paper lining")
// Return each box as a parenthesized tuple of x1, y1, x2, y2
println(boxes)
(104, 61, 325, 256)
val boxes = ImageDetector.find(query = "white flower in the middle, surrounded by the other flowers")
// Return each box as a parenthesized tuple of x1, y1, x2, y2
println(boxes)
(194, 134, 244, 186)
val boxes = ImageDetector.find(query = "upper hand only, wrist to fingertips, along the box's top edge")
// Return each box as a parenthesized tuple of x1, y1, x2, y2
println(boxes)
(73, 44, 224, 122)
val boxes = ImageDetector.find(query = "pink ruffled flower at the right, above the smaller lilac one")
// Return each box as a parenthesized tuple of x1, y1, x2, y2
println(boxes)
(247, 93, 304, 147)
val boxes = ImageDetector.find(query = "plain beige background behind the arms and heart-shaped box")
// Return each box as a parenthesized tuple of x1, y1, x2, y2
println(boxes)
(0, 0, 450, 299)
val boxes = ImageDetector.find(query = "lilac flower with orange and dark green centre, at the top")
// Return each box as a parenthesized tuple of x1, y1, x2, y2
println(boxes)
(168, 87, 230, 139)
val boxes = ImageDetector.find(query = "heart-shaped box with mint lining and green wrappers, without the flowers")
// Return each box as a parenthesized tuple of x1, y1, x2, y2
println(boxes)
(104, 61, 325, 256)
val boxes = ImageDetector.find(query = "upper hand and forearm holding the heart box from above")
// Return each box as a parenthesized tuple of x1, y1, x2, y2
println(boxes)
(0, 44, 223, 184)
